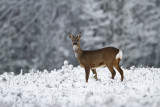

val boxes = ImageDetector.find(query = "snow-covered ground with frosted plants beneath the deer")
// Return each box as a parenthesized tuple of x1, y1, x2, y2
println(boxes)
(0, 61, 160, 107)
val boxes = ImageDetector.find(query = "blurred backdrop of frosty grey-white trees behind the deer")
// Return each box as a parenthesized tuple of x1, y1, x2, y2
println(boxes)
(0, 0, 160, 73)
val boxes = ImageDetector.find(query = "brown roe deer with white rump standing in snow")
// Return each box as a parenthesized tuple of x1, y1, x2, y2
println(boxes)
(69, 33, 123, 82)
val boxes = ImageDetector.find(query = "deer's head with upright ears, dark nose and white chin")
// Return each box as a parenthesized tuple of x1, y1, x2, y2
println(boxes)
(69, 32, 81, 51)
